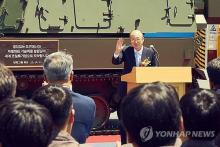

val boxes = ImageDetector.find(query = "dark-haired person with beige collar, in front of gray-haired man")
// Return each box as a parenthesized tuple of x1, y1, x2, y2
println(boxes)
(32, 84, 89, 147)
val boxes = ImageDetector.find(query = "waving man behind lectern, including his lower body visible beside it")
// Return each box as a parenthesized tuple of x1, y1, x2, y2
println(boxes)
(110, 30, 159, 144)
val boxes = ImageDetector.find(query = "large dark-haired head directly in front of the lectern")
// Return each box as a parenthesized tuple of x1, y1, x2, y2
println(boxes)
(121, 82, 181, 147)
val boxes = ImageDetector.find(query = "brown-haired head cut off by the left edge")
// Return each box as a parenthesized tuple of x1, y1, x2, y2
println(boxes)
(0, 63, 17, 101)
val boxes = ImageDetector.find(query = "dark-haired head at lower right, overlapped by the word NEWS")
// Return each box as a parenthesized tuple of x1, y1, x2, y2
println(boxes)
(180, 89, 220, 140)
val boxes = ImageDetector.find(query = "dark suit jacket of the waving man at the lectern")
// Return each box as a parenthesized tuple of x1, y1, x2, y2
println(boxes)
(112, 46, 159, 74)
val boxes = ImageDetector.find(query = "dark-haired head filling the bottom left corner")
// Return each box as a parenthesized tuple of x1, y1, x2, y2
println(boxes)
(0, 98, 53, 147)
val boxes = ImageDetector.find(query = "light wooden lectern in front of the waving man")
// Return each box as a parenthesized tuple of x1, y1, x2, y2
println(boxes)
(121, 67, 192, 98)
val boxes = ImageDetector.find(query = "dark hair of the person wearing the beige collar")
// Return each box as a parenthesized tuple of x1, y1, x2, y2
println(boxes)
(32, 84, 72, 130)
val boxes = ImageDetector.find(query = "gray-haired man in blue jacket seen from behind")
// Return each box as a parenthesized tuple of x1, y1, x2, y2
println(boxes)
(43, 52, 96, 143)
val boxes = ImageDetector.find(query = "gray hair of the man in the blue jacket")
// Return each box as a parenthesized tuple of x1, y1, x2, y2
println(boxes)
(43, 52, 73, 81)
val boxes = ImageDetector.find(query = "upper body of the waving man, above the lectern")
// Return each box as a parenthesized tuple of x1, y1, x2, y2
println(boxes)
(112, 30, 159, 74)
